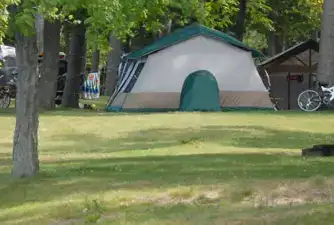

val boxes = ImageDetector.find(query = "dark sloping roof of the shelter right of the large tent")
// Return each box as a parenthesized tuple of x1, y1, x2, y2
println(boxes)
(258, 39, 319, 67)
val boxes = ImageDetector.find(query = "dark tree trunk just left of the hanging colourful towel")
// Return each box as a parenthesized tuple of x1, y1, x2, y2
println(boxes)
(62, 23, 86, 108)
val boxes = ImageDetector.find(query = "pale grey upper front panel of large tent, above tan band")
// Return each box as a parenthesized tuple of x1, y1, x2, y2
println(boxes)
(132, 36, 266, 93)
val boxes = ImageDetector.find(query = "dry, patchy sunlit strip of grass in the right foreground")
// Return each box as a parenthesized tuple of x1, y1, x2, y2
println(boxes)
(109, 177, 334, 208)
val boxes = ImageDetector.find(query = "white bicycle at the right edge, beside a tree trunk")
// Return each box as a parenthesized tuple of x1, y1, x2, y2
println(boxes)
(297, 85, 334, 112)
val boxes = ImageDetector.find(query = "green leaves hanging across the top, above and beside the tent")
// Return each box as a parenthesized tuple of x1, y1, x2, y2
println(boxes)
(0, 0, 323, 54)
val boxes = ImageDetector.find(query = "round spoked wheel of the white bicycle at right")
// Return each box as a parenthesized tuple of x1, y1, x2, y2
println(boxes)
(297, 90, 322, 112)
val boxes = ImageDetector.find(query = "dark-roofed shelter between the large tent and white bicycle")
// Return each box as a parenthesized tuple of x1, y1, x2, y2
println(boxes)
(258, 39, 319, 110)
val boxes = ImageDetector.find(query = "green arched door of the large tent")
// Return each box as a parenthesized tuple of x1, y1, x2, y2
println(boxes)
(180, 70, 220, 111)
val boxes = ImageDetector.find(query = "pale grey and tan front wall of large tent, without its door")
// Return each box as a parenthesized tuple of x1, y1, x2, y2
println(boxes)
(108, 36, 273, 109)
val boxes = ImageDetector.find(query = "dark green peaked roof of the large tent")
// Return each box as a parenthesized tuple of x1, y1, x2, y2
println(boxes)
(127, 23, 263, 59)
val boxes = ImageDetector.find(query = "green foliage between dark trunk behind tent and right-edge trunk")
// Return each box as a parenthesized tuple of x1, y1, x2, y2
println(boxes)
(241, 0, 323, 49)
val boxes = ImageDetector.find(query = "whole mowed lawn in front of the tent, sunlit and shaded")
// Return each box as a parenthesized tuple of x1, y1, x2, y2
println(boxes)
(0, 110, 334, 225)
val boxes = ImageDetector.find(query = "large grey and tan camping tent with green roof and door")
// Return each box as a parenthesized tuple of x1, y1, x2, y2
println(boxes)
(107, 24, 273, 111)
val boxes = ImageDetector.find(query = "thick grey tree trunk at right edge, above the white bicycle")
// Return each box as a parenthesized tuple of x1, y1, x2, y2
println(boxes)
(317, 0, 334, 85)
